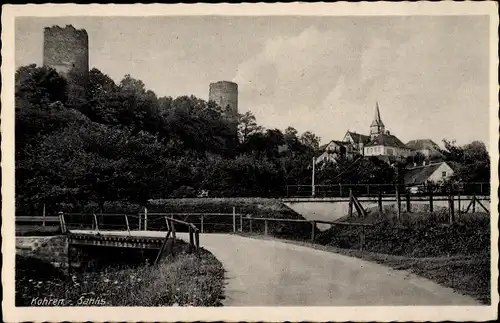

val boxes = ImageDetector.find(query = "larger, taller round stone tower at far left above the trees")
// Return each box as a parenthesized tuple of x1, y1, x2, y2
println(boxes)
(43, 25, 89, 97)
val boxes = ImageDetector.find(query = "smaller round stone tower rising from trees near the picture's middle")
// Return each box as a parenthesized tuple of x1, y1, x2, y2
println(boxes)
(208, 81, 238, 131)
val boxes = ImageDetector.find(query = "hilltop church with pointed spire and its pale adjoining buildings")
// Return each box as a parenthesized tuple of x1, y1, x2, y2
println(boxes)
(316, 102, 411, 163)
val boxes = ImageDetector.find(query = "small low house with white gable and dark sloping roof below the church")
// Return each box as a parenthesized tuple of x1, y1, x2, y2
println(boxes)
(403, 162, 454, 187)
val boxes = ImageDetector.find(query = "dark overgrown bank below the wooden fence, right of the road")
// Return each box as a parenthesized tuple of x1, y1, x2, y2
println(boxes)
(316, 212, 490, 257)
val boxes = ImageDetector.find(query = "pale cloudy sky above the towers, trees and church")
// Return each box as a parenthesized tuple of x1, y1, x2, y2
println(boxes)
(15, 16, 490, 146)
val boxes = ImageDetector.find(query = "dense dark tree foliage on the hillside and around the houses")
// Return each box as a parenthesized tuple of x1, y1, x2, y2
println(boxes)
(15, 65, 489, 213)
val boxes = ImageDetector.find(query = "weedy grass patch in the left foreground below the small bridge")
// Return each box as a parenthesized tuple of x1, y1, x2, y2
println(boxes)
(16, 240, 224, 306)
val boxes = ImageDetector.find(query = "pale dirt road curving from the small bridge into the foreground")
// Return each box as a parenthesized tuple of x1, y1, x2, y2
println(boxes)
(188, 234, 479, 306)
